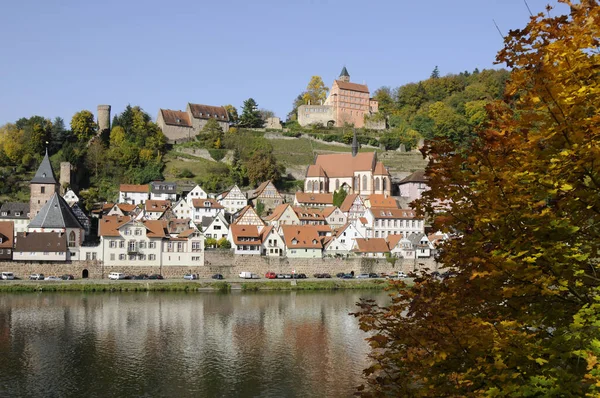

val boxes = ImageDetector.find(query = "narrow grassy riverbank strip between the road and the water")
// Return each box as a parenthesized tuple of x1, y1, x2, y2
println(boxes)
(0, 279, 404, 293)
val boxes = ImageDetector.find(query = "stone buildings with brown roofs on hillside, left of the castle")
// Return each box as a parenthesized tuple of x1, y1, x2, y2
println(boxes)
(156, 103, 229, 144)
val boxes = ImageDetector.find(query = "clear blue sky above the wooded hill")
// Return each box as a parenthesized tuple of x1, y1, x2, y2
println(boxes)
(0, 0, 567, 125)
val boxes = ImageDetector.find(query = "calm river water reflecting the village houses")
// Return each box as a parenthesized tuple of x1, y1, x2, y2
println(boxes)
(0, 291, 388, 397)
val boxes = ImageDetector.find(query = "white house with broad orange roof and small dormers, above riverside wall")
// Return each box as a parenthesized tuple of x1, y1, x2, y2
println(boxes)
(281, 225, 323, 258)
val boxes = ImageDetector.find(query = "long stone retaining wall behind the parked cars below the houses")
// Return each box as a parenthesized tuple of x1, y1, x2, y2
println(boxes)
(0, 250, 441, 279)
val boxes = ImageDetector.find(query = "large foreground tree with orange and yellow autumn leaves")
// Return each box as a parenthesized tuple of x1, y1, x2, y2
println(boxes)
(356, 0, 600, 397)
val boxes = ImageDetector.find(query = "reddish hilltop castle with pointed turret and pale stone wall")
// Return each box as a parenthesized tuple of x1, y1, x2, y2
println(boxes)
(298, 66, 385, 130)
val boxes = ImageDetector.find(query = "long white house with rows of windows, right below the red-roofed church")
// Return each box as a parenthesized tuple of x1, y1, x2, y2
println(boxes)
(365, 208, 425, 238)
